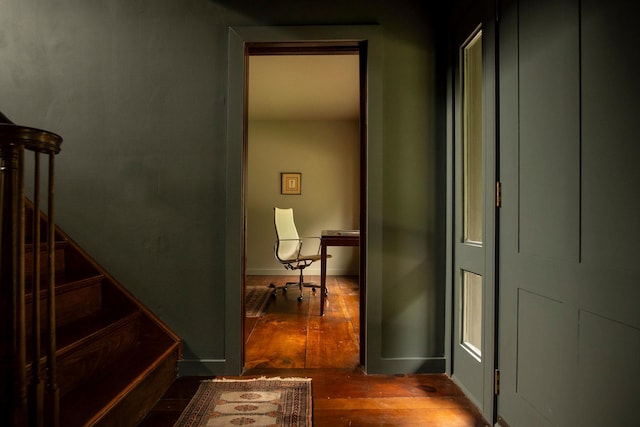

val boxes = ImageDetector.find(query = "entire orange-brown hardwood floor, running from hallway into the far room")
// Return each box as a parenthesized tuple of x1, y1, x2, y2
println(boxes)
(139, 276, 489, 427)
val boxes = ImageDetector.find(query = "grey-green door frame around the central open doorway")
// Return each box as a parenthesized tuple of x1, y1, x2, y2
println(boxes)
(224, 26, 382, 374)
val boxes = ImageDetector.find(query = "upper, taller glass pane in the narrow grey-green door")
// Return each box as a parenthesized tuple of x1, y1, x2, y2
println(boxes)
(461, 31, 483, 243)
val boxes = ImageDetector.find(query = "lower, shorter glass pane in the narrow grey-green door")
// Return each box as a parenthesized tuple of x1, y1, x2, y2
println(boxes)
(460, 270, 482, 358)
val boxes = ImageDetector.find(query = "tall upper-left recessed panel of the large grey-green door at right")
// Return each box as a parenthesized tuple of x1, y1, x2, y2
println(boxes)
(518, 0, 580, 261)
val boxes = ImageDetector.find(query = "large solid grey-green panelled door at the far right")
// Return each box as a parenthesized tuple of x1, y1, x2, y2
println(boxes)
(498, 0, 640, 427)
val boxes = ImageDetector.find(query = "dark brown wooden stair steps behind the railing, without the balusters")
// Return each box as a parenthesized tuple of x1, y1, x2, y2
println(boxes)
(25, 204, 182, 427)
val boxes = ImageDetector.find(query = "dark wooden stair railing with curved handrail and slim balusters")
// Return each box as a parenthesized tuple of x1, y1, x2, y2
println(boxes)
(0, 113, 62, 427)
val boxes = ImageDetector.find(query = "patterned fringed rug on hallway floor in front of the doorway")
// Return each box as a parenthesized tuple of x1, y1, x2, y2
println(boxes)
(174, 377, 313, 427)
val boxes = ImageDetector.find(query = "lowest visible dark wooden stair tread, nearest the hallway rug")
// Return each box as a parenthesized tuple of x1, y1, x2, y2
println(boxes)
(60, 342, 178, 426)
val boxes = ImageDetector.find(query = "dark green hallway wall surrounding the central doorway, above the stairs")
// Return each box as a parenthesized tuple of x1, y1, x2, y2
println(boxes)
(0, 0, 444, 372)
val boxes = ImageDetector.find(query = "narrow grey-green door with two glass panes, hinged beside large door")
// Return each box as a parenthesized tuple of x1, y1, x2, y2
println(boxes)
(453, 27, 485, 406)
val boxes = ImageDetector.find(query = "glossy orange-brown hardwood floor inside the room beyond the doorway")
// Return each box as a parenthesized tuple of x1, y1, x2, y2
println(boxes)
(245, 276, 360, 371)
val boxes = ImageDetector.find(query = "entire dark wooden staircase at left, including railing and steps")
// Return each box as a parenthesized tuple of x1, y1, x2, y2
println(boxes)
(0, 112, 182, 427)
